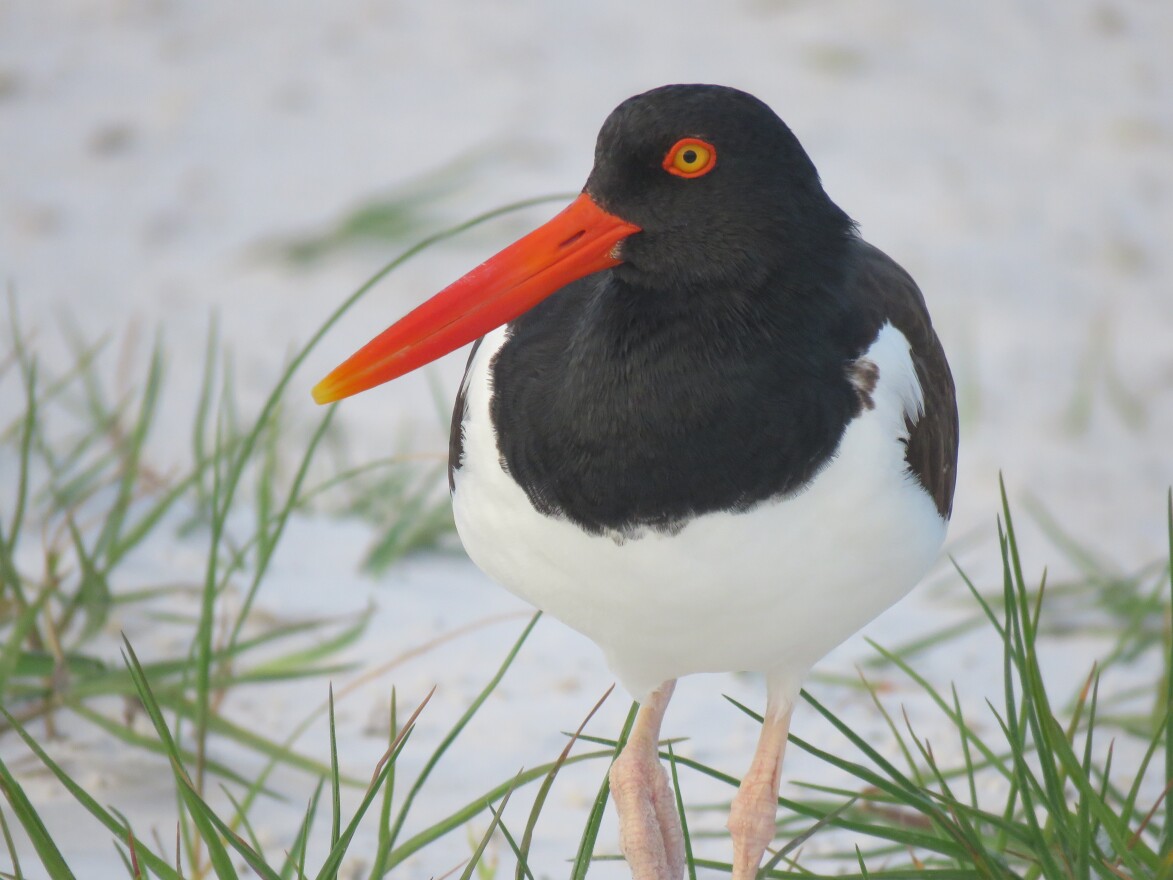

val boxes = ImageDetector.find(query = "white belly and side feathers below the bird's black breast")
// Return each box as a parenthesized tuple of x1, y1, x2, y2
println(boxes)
(453, 325, 947, 699)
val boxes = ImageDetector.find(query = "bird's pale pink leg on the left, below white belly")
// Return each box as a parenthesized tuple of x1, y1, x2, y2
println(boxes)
(610, 681, 684, 880)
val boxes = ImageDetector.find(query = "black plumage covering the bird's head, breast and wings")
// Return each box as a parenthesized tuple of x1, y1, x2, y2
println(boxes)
(450, 86, 957, 536)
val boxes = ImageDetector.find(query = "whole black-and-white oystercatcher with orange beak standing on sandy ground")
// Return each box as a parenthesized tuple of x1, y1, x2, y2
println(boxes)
(313, 84, 958, 880)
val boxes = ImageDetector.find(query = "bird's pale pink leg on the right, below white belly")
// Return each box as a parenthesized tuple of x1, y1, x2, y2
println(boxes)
(726, 689, 794, 880)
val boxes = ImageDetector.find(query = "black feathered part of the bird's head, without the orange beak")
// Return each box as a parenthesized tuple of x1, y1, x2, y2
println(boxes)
(584, 86, 853, 290)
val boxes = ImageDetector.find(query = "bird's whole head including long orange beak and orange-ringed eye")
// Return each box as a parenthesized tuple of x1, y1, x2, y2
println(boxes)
(313, 86, 850, 404)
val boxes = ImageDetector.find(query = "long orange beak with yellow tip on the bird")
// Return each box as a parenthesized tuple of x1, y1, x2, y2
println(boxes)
(313, 192, 639, 404)
